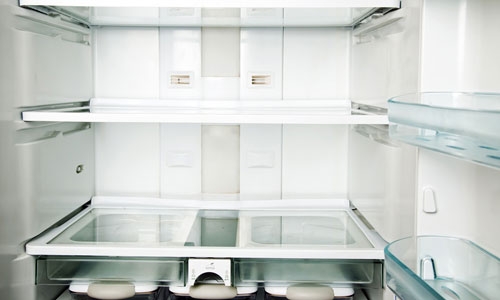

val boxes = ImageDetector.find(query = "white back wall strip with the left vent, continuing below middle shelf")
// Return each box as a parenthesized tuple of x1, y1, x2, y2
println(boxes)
(160, 27, 203, 198)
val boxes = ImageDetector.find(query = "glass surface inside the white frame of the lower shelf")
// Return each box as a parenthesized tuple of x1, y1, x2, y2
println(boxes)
(50, 208, 373, 249)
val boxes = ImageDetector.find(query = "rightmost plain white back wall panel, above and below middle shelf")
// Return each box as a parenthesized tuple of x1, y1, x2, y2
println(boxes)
(282, 28, 350, 199)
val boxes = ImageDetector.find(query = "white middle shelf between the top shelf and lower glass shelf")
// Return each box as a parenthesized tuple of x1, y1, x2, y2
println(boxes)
(22, 98, 388, 124)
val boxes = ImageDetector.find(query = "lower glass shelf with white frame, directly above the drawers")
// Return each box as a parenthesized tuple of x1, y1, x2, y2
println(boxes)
(26, 198, 385, 259)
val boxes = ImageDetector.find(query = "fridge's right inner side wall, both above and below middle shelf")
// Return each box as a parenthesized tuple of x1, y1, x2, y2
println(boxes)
(348, 0, 422, 241)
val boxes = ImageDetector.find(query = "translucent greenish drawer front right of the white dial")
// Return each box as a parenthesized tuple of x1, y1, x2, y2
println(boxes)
(234, 259, 384, 288)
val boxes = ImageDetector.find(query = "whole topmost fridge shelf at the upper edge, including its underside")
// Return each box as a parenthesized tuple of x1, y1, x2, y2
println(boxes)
(20, 0, 400, 27)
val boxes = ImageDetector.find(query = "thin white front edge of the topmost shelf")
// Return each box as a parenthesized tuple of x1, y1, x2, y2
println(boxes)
(19, 0, 400, 8)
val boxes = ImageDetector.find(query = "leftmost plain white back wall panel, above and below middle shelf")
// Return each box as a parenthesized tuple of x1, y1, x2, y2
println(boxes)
(94, 27, 160, 197)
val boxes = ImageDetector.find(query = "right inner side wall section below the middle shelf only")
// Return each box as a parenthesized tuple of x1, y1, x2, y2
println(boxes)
(348, 130, 416, 241)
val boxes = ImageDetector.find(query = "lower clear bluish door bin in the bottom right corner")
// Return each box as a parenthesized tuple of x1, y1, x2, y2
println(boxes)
(385, 236, 500, 300)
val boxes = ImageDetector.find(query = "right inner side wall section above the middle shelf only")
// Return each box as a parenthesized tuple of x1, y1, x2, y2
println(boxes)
(350, 0, 422, 105)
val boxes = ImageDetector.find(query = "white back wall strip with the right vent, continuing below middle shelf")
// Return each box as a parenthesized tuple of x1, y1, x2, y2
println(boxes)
(240, 28, 283, 200)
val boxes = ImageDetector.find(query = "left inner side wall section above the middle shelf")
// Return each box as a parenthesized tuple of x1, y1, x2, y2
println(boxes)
(0, 6, 92, 106)
